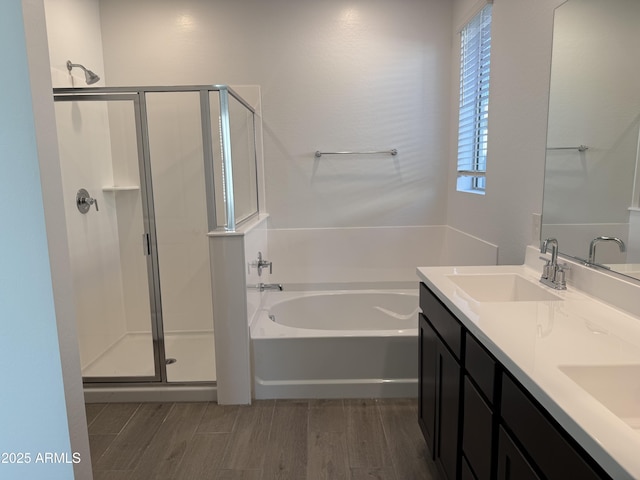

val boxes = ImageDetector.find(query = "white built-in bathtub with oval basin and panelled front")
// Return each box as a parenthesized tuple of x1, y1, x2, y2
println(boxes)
(250, 285, 418, 399)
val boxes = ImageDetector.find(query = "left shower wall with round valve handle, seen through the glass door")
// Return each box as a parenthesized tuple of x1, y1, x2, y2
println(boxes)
(55, 98, 132, 368)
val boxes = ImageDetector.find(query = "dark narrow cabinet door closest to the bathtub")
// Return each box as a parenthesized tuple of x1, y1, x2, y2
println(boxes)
(418, 314, 438, 458)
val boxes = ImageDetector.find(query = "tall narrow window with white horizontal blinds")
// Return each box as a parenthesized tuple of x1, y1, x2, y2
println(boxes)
(457, 4, 491, 194)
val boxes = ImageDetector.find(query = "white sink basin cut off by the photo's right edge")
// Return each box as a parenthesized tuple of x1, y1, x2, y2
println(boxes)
(558, 365, 640, 430)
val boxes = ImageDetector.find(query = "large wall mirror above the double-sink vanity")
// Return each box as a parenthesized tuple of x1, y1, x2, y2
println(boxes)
(541, 0, 640, 279)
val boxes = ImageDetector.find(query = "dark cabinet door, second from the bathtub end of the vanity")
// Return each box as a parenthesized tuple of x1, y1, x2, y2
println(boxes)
(435, 340, 461, 480)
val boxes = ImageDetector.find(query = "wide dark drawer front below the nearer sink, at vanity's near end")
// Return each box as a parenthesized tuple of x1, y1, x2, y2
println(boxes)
(501, 374, 609, 480)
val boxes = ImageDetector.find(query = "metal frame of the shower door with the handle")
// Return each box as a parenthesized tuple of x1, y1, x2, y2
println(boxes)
(53, 93, 167, 384)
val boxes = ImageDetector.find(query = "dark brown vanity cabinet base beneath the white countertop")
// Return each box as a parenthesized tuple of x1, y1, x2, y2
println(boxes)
(418, 283, 611, 480)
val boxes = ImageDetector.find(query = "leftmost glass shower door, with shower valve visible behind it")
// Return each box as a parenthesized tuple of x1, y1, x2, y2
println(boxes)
(54, 94, 164, 382)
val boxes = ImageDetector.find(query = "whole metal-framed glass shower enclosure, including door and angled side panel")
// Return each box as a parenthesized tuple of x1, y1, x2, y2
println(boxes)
(54, 85, 258, 385)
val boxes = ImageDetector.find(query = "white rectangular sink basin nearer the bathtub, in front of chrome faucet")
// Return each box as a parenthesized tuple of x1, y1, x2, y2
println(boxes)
(447, 273, 562, 302)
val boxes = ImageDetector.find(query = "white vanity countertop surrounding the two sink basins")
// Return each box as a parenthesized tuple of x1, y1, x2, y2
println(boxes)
(417, 258, 640, 479)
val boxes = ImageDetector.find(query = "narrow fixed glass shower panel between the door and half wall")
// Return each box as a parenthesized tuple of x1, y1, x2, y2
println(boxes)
(145, 90, 216, 383)
